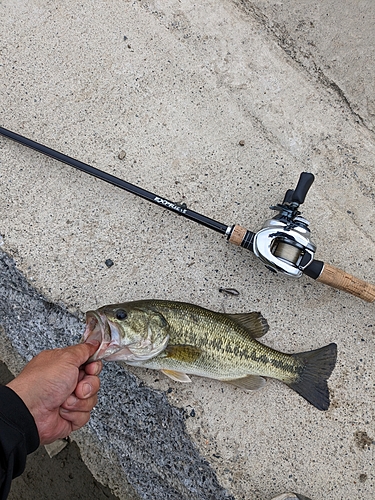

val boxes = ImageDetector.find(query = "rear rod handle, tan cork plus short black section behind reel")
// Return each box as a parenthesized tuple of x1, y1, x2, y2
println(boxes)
(304, 260, 375, 302)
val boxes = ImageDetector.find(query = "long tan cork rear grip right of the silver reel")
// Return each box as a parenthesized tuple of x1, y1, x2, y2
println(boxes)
(316, 264, 375, 302)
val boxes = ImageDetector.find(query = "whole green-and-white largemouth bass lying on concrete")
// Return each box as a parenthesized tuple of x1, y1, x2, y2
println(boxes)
(82, 299, 337, 411)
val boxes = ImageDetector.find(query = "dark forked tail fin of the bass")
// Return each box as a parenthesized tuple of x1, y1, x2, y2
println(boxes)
(288, 343, 337, 410)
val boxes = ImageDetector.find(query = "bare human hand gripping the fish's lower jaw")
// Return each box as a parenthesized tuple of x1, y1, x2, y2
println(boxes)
(7, 342, 102, 444)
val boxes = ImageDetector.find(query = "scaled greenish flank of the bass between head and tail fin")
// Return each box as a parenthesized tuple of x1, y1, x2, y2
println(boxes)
(142, 304, 302, 381)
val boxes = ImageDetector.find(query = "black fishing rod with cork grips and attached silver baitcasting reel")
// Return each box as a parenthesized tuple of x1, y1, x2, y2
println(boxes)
(0, 127, 375, 302)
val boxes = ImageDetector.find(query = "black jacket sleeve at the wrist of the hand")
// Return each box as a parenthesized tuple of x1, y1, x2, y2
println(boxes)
(0, 386, 39, 500)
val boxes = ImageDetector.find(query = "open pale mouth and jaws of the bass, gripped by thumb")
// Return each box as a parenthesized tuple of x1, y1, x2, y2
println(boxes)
(82, 311, 126, 363)
